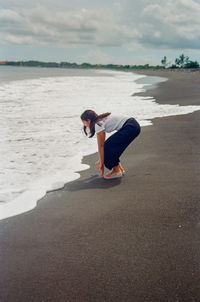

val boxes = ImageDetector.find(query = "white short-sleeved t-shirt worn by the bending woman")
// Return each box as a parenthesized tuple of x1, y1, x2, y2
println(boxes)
(95, 114, 130, 133)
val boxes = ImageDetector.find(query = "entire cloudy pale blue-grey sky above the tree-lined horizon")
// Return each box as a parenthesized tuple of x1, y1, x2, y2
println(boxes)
(0, 0, 200, 65)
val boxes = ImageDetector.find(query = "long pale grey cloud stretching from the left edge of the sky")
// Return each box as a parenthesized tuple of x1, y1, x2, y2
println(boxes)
(0, 5, 138, 47)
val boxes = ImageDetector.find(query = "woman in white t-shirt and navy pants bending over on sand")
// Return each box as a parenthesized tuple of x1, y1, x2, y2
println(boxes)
(81, 110, 141, 179)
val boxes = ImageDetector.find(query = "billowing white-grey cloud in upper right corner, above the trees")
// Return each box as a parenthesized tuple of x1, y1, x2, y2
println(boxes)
(140, 0, 200, 48)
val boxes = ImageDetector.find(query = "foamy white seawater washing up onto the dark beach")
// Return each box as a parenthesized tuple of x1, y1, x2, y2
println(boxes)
(0, 67, 200, 219)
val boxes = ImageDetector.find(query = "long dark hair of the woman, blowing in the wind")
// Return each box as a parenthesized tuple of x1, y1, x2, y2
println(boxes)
(81, 110, 110, 137)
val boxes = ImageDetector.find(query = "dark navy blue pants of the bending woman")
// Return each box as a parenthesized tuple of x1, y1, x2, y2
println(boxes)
(104, 118, 141, 170)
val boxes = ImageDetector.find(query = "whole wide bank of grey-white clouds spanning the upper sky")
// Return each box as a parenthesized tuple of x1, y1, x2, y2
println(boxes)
(0, 0, 200, 49)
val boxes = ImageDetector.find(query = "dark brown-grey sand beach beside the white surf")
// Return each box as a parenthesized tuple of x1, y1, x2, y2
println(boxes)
(0, 71, 200, 302)
